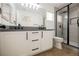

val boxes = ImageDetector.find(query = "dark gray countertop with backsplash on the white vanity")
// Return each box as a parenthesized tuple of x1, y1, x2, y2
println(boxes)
(0, 26, 55, 32)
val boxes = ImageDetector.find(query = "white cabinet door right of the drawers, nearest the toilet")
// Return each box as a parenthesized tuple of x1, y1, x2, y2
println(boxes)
(41, 31, 53, 51)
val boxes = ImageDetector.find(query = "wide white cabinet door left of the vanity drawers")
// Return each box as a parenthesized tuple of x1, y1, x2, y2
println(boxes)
(0, 32, 31, 55)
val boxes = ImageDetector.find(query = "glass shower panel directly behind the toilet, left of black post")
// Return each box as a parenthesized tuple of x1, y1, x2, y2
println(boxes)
(57, 7, 68, 43)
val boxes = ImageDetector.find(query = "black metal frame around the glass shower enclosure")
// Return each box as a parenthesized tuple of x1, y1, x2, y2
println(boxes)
(55, 3, 78, 48)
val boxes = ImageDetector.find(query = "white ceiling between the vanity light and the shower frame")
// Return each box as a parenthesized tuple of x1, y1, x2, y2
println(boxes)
(16, 3, 69, 10)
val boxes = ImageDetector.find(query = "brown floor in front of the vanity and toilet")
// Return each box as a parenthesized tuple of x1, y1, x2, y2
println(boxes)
(36, 44, 79, 56)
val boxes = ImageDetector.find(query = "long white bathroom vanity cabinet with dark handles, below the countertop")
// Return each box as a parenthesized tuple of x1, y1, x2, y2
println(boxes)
(0, 30, 55, 56)
